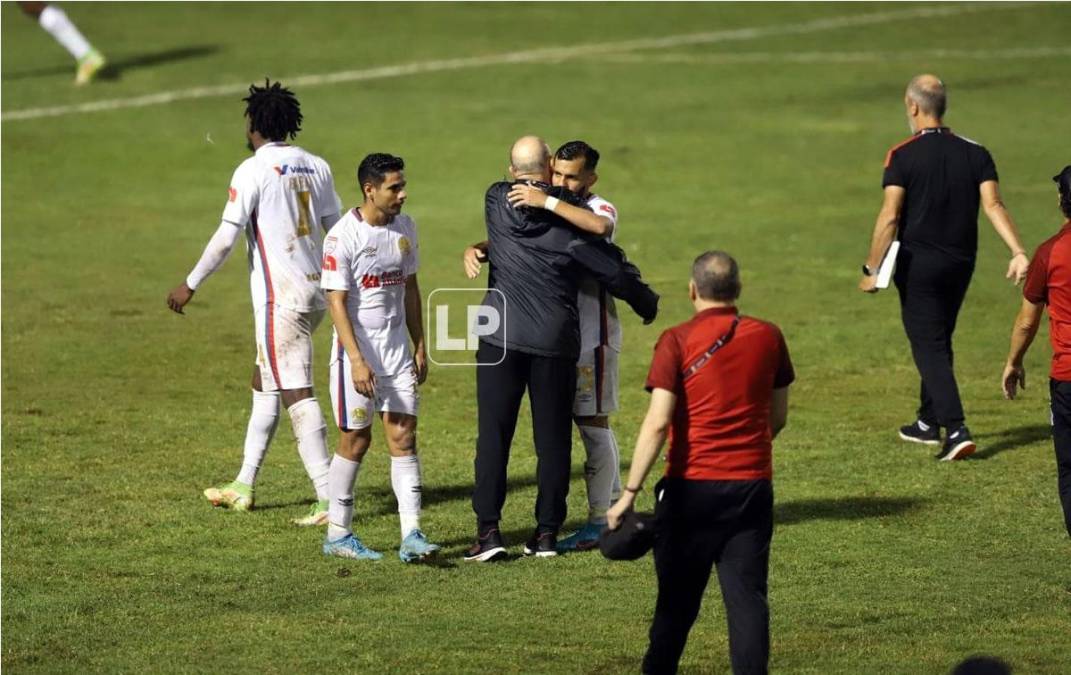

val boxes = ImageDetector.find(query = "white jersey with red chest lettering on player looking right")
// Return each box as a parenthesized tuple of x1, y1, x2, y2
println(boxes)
(320, 209, 419, 376)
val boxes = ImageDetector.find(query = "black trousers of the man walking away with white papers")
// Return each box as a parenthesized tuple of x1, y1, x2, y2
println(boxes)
(896, 251, 975, 430)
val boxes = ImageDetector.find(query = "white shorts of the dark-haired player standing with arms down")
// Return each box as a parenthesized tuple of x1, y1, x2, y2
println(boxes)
(330, 341, 420, 431)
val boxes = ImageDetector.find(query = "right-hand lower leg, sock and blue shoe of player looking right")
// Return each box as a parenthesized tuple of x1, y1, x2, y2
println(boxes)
(382, 411, 439, 563)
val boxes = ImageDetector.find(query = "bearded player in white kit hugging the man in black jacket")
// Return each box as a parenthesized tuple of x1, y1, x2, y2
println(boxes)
(509, 140, 621, 552)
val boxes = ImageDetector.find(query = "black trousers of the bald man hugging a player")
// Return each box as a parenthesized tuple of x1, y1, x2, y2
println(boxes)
(472, 341, 576, 533)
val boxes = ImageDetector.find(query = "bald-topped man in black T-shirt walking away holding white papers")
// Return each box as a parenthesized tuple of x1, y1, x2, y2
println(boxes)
(859, 75, 1029, 461)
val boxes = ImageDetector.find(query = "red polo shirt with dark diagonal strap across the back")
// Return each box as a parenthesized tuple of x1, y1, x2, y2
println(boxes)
(647, 308, 796, 480)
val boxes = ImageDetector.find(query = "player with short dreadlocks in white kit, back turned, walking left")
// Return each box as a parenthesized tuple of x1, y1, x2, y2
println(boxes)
(167, 81, 338, 525)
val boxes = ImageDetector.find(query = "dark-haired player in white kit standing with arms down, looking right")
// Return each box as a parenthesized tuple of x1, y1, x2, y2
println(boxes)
(320, 153, 439, 563)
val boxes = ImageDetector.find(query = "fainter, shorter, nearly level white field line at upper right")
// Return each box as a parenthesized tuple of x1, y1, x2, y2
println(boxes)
(595, 47, 1071, 65)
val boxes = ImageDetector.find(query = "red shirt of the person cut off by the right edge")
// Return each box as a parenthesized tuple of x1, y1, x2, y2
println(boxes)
(1023, 221, 1071, 381)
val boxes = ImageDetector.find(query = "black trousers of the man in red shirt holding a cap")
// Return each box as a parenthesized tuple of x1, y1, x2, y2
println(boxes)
(644, 479, 773, 675)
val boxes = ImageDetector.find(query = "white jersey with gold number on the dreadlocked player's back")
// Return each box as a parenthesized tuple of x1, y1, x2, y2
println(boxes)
(223, 143, 338, 312)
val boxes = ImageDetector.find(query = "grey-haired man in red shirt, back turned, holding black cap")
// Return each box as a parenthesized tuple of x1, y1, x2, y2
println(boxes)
(607, 251, 795, 674)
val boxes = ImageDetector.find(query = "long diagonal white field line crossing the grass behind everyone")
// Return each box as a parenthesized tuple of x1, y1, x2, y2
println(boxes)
(0, 2, 1034, 122)
